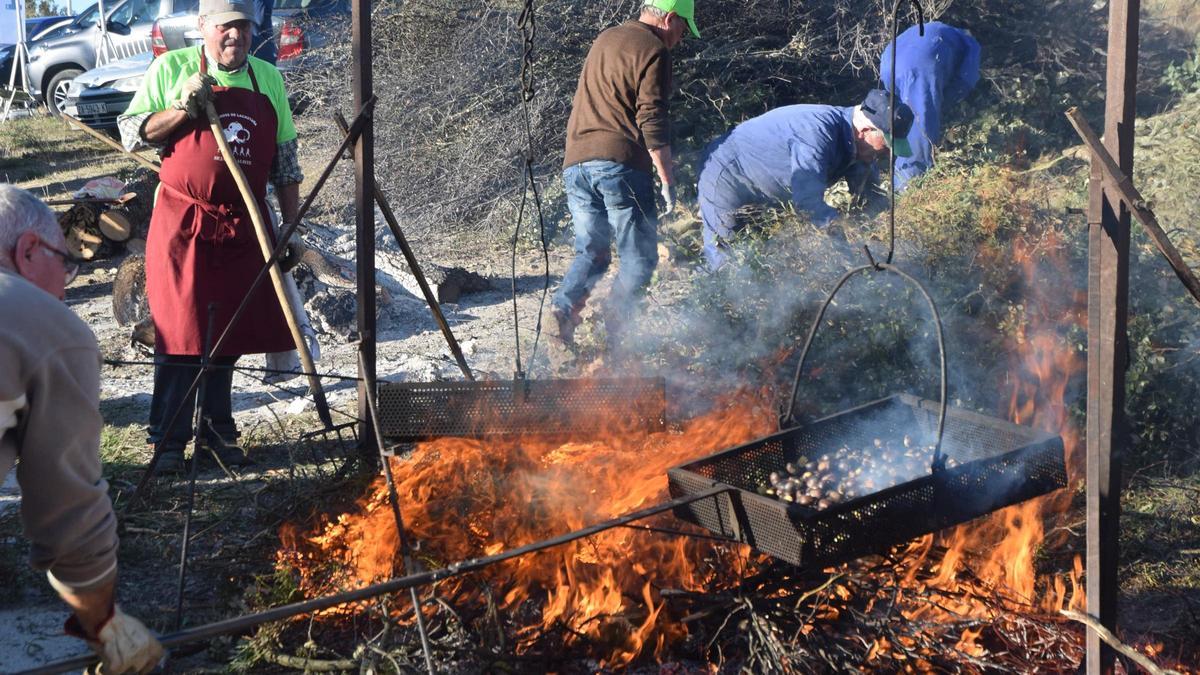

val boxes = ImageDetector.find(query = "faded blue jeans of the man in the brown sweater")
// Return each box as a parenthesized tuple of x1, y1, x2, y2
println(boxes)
(553, 160, 659, 316)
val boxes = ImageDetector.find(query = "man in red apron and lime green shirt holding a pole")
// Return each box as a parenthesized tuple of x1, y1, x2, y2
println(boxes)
(119, 0, 304, 471)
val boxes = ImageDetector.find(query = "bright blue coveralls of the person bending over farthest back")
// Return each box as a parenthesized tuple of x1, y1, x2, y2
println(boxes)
(880, 22, 979, 192)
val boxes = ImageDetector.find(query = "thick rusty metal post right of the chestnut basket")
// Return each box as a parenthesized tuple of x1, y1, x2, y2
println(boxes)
(1087, 0, 1141, 675)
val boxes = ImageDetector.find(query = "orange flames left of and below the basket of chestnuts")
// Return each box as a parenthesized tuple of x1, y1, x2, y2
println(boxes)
(281, 395, 775, 667)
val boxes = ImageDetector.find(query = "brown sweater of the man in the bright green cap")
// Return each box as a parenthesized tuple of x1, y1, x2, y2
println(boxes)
(563, 19, 671, 173)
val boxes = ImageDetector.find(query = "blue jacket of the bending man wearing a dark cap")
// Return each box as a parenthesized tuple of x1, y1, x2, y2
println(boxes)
(700, 104, 872, 225)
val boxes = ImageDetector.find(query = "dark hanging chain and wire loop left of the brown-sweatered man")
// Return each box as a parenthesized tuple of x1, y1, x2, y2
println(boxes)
(511, 0, 550, 380)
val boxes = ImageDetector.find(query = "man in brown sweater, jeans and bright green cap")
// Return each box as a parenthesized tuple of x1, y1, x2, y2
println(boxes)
(553, 0, 700, 344)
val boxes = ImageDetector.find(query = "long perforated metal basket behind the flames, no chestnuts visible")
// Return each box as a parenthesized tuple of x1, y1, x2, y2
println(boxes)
(379, 377, 666, 442)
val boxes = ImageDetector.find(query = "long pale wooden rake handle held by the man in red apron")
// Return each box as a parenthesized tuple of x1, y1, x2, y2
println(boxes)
(204, 101, 334, 429)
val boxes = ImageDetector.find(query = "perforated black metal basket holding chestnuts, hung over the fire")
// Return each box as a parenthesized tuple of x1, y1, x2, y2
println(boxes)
(667, 394, 1067, 566)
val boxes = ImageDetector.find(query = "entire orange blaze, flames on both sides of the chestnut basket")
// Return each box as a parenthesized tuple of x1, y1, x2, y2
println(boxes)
(280, 228, 1108, 669)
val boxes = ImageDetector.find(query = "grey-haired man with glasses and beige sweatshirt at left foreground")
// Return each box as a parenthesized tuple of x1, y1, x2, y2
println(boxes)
(0, 184, 163, 673)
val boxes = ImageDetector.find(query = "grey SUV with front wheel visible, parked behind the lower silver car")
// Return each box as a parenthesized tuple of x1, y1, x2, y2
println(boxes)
(29, 0, 162, 115)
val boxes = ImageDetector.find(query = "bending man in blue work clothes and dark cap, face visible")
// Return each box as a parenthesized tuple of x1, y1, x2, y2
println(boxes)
(697, 89, 912, 269)
